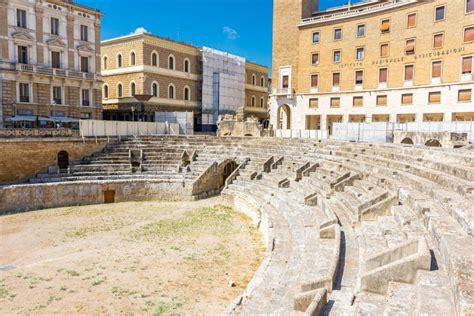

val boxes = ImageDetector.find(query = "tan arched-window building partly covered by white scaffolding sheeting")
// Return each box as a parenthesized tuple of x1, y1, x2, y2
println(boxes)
(102, 33, 268, 131)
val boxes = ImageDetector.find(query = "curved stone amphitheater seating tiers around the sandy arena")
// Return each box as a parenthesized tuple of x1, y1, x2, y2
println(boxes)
(0, 136, 474, 315)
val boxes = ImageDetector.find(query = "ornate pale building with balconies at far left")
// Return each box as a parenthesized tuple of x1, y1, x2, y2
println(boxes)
(0, 0, 102, 128)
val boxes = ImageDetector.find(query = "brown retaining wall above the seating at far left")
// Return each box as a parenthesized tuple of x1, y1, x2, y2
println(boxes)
(0, 138, 112, 183)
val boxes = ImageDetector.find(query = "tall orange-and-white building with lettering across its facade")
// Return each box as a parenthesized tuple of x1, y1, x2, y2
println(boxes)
(270, 0, 474, 132)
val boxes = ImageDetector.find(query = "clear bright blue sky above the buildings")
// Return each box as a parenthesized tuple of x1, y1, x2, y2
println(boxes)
(81, 0, 362, 66)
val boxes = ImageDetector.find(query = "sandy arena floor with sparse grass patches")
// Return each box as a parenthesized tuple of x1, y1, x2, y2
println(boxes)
(0, 199, 264, 315)
